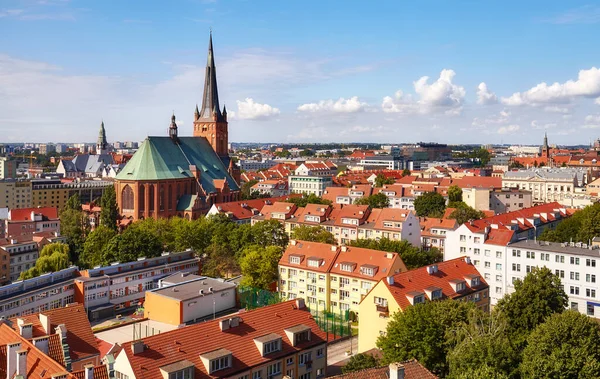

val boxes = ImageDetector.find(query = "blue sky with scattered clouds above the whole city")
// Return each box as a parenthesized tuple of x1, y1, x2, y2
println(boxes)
(0, 0, 600, 144)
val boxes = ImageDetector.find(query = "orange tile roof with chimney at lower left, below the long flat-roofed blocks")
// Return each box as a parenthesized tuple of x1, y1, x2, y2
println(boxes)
(10, 304, 100, 361)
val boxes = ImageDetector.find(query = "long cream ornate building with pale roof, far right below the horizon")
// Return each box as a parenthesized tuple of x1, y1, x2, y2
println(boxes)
(502, 167, 586, 204)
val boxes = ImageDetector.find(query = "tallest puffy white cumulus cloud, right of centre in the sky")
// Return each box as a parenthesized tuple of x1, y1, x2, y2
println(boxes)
(381, 69, 466, 114)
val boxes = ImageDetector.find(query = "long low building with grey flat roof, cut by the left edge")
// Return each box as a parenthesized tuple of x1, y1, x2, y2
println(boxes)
(0, 266, 78, 319)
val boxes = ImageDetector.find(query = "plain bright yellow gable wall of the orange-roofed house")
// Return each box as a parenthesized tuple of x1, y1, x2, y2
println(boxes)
(358, 280, 402, 352)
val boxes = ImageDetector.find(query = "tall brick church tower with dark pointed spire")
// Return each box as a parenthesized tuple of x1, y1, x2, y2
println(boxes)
(194, 32, 229, 158)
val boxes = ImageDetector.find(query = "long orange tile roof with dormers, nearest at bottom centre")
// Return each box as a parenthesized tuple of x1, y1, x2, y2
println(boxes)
(119, 300, 327, 379)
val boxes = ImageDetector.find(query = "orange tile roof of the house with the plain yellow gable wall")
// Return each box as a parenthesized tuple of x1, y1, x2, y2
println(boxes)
(381, 257, 488, 309)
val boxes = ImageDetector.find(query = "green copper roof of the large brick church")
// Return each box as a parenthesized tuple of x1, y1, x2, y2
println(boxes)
(117, 137, 239, 193)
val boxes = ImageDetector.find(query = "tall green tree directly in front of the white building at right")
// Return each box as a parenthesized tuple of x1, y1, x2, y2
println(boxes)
(496, 267, 568, 346)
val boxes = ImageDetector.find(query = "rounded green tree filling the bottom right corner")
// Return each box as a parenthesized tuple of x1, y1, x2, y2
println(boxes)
(521, 310, 600, 379)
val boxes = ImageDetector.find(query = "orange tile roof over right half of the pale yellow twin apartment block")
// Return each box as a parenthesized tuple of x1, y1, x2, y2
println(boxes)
(330, 246, 406, 281)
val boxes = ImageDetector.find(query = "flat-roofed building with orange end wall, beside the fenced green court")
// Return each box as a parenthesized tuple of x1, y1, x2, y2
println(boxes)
(144, 273, 236, 325)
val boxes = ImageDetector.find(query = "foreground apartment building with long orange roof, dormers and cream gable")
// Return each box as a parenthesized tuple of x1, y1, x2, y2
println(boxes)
(114, 299, 327, 379)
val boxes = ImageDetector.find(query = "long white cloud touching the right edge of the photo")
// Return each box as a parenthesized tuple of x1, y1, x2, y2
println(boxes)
(502, 67, 600, 106)
